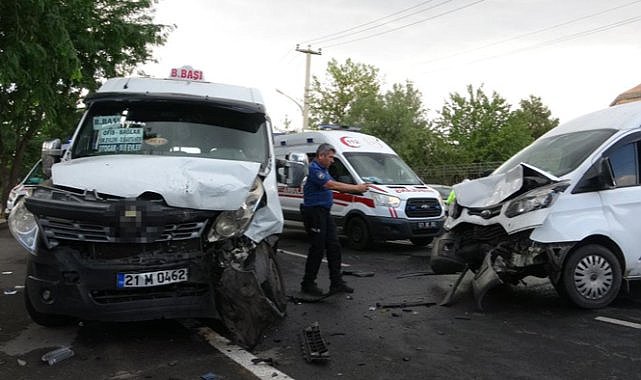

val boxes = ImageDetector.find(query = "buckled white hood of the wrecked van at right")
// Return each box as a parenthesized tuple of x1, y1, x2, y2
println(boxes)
(454, 163, 560, 208)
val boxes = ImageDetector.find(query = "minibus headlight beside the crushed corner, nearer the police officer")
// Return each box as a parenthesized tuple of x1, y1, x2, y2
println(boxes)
(207, 177, 265, 242)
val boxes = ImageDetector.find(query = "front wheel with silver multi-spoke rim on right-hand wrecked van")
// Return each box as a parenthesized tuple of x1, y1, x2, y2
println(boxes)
(559, 244, 621, 309)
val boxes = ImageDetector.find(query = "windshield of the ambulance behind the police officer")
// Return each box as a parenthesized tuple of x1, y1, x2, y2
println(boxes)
(344, 152, 423, 185)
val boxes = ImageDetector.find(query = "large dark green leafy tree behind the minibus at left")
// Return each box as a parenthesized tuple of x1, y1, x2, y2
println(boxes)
(0, 0, 172, 215)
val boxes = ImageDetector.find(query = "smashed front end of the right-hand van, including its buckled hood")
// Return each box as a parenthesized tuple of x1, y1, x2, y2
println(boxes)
(431, 164, 572, 309)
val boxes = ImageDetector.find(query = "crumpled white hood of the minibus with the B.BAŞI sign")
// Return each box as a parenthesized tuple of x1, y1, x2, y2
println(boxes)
(52, 155, 260, 211)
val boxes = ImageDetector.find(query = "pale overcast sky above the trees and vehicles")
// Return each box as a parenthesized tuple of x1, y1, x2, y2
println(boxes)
(140, 0, 641, 130)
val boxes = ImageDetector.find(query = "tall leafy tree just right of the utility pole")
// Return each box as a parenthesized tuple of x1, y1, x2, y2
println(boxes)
(309, 59, 380, 125)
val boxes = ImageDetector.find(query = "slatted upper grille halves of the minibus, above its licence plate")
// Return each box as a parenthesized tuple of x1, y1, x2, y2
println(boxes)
(40, 217, 207, 243)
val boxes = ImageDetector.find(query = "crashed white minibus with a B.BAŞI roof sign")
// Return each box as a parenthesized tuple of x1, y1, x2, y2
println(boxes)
(8, 68, 304, 347)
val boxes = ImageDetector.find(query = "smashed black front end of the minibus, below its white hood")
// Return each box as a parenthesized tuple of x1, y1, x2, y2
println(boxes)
(16, 183, 286, 347)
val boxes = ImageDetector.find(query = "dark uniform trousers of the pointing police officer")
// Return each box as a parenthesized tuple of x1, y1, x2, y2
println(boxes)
(301, 205, 342, 285)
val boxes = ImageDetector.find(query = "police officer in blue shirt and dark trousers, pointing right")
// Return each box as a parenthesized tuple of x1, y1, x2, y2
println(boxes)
(301, 144, 369, 296)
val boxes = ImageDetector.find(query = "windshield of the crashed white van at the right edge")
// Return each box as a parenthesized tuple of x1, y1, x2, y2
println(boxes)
(493, 129, 616, 177)
